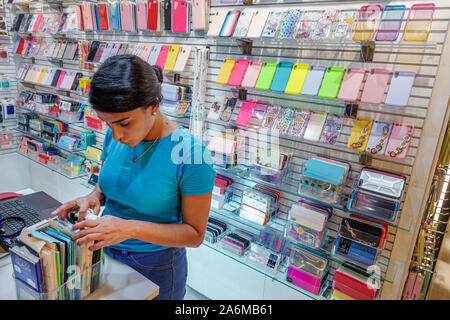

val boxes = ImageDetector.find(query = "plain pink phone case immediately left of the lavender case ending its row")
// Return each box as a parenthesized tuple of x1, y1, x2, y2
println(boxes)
(361, 68, 391, 104)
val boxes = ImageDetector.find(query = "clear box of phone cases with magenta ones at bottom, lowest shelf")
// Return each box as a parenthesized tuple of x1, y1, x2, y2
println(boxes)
(286, 247, 329, 294)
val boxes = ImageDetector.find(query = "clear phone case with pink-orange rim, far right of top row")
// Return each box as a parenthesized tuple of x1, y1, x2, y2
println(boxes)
(403, 3, 436, 42)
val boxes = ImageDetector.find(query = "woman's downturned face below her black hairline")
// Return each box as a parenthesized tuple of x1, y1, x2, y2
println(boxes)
(96, 107, 156, 147)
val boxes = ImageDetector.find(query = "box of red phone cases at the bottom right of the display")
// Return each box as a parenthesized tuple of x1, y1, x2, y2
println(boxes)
(331, 262, 380, 300)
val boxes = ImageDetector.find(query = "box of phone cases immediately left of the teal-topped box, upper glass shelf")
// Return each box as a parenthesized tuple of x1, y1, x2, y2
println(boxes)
(250, 148, 292, 185)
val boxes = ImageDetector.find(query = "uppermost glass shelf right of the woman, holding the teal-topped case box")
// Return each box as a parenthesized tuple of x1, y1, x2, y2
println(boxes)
(214, 165, 412, 232)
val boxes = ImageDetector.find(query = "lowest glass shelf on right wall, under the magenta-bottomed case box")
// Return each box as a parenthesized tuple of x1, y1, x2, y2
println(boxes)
(203, 240, 326, 300)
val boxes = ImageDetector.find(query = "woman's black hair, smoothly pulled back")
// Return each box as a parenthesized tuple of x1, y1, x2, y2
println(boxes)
(89, 55, 163, 112)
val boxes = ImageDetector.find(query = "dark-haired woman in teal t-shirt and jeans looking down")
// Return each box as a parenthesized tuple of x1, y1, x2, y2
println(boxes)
(53, 55, 216, 299)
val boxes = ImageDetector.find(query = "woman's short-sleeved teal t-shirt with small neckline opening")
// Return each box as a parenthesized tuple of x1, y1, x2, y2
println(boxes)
(98, 127, 216, 252)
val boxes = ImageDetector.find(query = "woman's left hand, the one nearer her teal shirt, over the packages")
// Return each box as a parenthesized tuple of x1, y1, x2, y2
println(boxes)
(72, 215, 132, 251)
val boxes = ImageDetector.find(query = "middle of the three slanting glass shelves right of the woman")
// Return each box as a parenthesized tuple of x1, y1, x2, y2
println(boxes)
(210, 208, 393, 283)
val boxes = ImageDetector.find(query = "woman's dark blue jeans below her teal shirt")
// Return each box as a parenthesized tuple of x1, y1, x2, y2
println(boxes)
(103, 247, 187, 300)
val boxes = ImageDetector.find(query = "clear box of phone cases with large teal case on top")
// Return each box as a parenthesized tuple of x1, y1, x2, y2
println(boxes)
(298, 156, 351, 203)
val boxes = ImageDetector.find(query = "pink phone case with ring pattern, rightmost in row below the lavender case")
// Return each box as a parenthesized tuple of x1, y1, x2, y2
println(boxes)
(385, 123, 414, 159)
